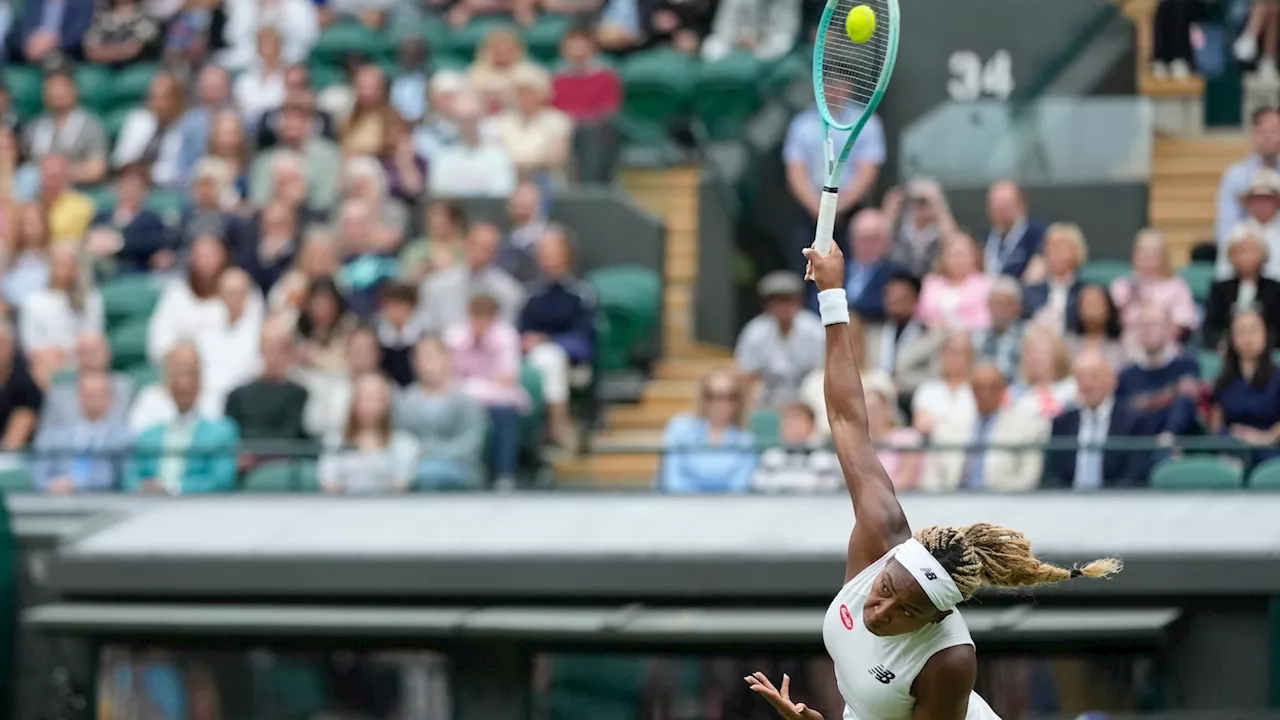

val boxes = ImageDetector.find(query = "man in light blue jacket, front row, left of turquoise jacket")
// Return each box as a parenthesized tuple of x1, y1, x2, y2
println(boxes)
(33, 370, 132, 495)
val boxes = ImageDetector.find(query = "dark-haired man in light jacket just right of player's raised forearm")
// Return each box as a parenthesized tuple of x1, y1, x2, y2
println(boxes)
(864, 272, 946, 399)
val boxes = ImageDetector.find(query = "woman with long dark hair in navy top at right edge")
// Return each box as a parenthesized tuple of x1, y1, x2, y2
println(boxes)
(1210, 307, 1280, 462)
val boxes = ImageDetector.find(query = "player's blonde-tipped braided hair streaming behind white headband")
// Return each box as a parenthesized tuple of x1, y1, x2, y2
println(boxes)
(915, 523, 1124, 600)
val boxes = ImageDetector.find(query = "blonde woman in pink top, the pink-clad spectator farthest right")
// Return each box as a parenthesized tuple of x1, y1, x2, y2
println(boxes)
(1111, 229, 1199, 356)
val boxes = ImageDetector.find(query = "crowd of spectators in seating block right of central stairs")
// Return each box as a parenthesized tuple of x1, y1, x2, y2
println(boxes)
(659, 102, 1280, 492)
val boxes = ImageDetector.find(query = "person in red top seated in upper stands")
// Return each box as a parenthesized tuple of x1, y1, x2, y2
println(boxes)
(552, 27, 622, 123)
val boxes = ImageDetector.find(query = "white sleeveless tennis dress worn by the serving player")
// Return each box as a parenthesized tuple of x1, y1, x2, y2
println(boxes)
(822, 551, 1000, 720)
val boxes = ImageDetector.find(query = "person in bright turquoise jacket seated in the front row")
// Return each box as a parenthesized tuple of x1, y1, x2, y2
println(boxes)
(124, 343, 239, 495)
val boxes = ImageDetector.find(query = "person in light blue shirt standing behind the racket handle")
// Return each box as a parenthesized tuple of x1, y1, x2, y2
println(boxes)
(782, 94, 884, 273)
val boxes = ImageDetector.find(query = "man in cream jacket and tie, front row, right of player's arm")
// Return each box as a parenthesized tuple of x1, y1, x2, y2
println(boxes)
(920, 363, 1050, 492)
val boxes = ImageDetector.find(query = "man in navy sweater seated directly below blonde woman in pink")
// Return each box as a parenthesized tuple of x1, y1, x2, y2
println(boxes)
(1116, 304, 1201, 436)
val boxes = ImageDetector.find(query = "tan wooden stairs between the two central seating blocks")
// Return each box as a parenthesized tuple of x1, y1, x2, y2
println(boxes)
(556, 165, 733, 489)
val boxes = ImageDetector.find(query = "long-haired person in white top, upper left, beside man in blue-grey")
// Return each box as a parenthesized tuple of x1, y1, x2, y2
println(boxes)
(111, 73, 187, 187)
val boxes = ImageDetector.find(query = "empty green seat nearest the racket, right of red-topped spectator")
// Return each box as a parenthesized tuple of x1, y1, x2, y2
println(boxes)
(694, 53, 767, 140)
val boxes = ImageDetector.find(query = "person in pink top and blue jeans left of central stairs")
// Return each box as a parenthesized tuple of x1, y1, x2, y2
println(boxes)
(444, 295, 529, 489)
